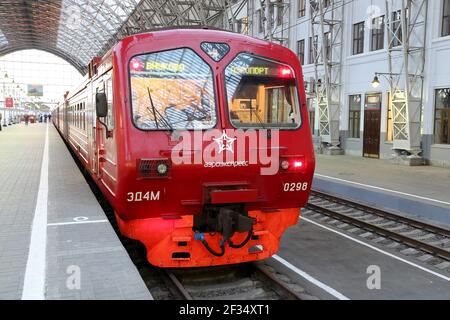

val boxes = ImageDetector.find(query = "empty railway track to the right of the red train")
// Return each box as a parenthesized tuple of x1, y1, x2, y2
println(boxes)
(303, 191, 450, 272)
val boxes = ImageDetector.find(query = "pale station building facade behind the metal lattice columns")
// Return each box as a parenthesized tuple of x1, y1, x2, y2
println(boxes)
(235, 0, 450, 167)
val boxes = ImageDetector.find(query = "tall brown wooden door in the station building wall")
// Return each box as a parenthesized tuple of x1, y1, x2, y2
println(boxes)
(363, 93, 381, 158)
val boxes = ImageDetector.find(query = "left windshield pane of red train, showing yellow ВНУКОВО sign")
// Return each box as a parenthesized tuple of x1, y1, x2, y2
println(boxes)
(129, 48, 217, 130)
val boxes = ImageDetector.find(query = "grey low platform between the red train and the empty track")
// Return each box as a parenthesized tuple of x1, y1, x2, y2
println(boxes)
(271, 218, 450, 300)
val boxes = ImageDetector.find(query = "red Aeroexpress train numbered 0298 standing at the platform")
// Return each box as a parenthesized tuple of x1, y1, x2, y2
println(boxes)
(52, 29, 315, 267)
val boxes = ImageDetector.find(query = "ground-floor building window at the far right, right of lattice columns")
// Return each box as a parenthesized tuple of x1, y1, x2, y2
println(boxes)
(434, 88, 450, 144)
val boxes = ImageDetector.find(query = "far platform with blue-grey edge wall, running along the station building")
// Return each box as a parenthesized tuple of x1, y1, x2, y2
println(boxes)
(313, 154, 450, 228)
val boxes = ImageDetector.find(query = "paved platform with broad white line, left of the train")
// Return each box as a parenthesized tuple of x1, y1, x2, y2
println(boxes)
(0, 123, 152, 300)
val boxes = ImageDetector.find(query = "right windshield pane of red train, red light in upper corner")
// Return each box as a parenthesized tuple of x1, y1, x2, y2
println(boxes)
(225, 53, 300, 129)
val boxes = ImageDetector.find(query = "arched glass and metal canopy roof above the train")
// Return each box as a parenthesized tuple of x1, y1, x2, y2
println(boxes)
(0, 0, 229, 73)
